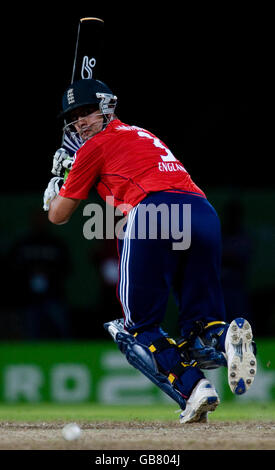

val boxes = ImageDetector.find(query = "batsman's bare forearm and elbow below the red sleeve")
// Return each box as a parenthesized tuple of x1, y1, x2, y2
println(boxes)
(48, 195, 81, 225)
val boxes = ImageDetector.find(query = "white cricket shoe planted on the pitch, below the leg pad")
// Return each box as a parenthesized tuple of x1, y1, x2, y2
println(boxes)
(180, 379, 220, 424)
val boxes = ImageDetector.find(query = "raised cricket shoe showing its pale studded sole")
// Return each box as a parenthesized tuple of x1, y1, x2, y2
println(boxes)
(225, 318, 257, 395)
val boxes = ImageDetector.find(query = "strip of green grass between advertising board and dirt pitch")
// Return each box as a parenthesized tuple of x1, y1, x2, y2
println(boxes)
(0, 402, 275, 422)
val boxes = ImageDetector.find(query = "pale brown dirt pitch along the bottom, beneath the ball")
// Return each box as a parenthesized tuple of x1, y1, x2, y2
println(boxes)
(0, 421, 275, 450)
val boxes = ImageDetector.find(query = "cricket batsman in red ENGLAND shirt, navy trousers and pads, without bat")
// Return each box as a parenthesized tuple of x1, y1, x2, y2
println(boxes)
(44, 78, 256, 423)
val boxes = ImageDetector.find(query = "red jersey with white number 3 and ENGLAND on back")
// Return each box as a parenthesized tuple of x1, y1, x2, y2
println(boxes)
(59, 119, 205, 206)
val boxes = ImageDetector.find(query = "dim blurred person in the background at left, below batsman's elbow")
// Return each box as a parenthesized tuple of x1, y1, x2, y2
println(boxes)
(8, 210, 70, 340)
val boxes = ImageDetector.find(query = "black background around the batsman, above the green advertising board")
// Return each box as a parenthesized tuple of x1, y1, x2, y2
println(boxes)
(0, 2, 275, 339)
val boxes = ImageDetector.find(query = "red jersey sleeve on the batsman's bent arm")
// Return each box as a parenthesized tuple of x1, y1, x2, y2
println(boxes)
(59, 143, 103, 199)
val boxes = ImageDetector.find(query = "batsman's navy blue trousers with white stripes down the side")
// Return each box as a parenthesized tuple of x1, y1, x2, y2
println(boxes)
(118, 191, 225, 336)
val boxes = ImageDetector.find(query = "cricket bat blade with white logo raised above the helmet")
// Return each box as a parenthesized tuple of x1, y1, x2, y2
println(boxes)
(71, 17, 104, 83)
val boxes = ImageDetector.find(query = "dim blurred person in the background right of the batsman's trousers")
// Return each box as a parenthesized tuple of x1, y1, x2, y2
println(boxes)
(222, 200, 252, 322)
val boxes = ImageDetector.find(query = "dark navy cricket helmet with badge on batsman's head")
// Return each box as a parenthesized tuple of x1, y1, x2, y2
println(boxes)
(59, 78, 117, 120)
